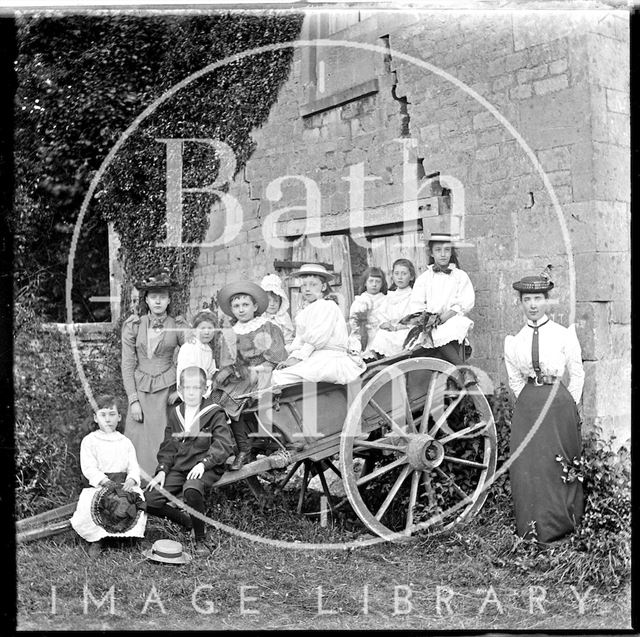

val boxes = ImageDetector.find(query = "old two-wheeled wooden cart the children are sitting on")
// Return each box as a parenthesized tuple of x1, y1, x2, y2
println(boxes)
(13, 353, 497, 541)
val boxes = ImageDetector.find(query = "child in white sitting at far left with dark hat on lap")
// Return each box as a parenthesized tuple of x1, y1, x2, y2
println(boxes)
(71, 395, 147, 557)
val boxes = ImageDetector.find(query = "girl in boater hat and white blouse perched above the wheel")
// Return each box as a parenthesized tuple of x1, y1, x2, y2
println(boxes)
(409, 234, 476, 385)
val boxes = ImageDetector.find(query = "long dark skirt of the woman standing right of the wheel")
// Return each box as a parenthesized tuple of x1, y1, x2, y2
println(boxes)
(509, 384, 584, 542)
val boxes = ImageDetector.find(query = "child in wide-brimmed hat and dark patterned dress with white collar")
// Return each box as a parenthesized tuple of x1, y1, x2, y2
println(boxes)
(213, 280, 287, 471)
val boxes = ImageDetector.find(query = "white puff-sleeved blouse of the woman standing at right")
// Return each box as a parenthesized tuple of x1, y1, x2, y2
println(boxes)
(504, 316, 584, 404)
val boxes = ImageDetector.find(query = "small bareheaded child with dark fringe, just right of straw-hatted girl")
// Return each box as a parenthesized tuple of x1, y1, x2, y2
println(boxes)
(349, 266, 387, 360)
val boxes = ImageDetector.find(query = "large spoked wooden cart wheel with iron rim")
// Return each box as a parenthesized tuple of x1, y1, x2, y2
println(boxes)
(340, 358, 497, 540)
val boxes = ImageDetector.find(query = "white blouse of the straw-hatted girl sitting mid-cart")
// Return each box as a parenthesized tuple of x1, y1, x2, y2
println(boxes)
(287, 299, 348, 360)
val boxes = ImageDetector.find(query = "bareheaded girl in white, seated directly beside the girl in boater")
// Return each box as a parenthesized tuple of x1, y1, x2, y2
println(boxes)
(369, 259, 416, 357)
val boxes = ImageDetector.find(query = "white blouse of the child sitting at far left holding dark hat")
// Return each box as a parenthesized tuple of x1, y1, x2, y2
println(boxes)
(80, 429, 140, 487)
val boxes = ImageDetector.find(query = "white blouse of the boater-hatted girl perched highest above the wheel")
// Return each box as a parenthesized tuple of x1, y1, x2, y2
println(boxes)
(409, 264, 476, 314)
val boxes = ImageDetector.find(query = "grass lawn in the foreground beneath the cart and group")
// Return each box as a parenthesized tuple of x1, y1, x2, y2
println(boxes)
(17, 486, 630, 630)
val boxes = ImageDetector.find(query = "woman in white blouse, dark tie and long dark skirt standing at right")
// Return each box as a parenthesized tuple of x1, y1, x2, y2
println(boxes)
(504, 274, 584, 543)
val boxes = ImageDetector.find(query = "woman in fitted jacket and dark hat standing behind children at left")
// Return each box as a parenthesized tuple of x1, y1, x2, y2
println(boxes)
(121, 270, 188, 482)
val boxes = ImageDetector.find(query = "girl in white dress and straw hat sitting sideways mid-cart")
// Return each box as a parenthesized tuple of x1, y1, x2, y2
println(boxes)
(271, 263, 366, 385)
